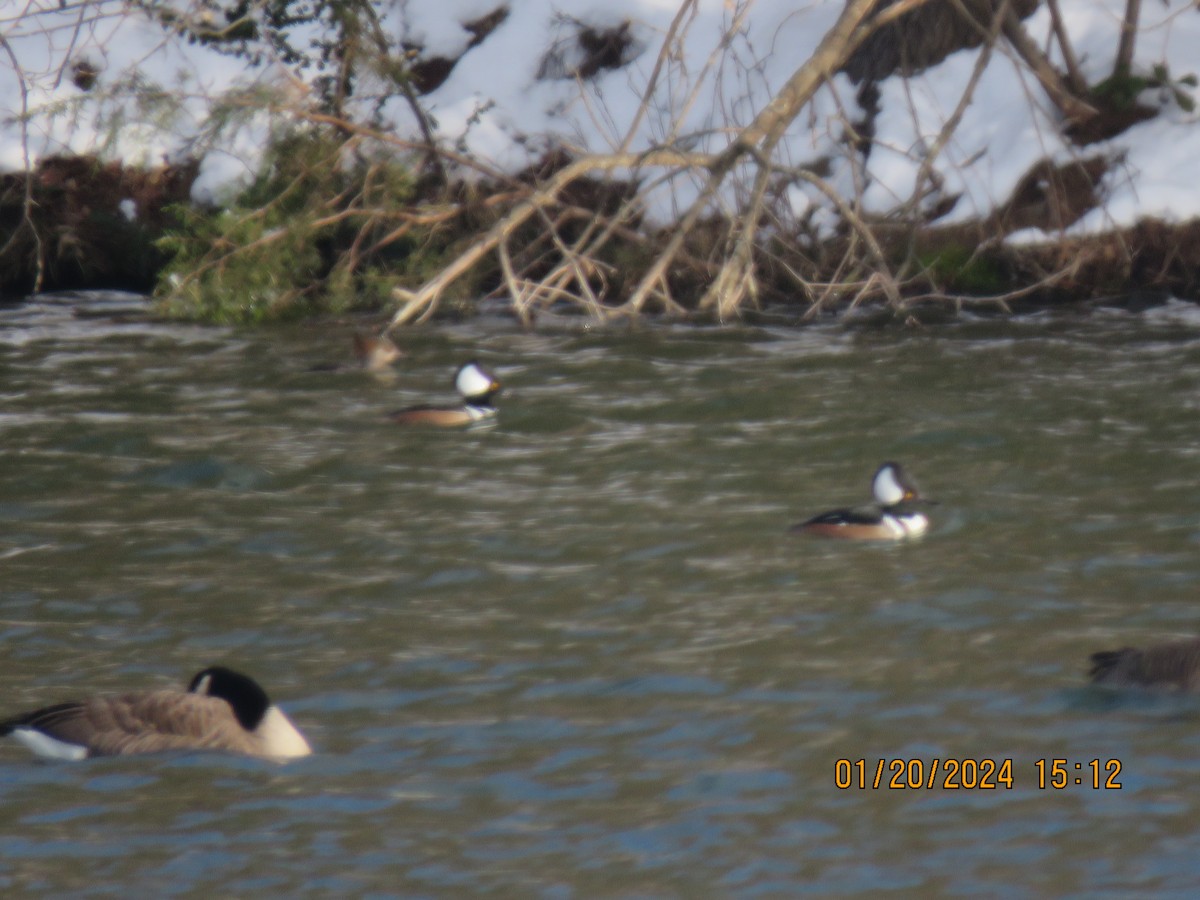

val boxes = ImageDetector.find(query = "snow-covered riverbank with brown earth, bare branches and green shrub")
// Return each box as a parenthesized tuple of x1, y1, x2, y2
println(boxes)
(0, 0, 1200, 325)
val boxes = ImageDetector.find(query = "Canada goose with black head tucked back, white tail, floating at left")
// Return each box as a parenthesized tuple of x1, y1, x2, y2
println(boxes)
(0, 666, 312, 760)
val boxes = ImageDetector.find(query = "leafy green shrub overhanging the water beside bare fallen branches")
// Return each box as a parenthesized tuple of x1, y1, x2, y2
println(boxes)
(157, 127, 445, 324)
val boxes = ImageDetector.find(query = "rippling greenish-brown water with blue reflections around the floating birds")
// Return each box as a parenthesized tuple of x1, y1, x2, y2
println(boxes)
(0, 295, 1200, 898)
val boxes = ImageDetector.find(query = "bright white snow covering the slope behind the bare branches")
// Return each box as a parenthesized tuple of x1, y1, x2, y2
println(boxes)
(0, 0, 1200, 240)
